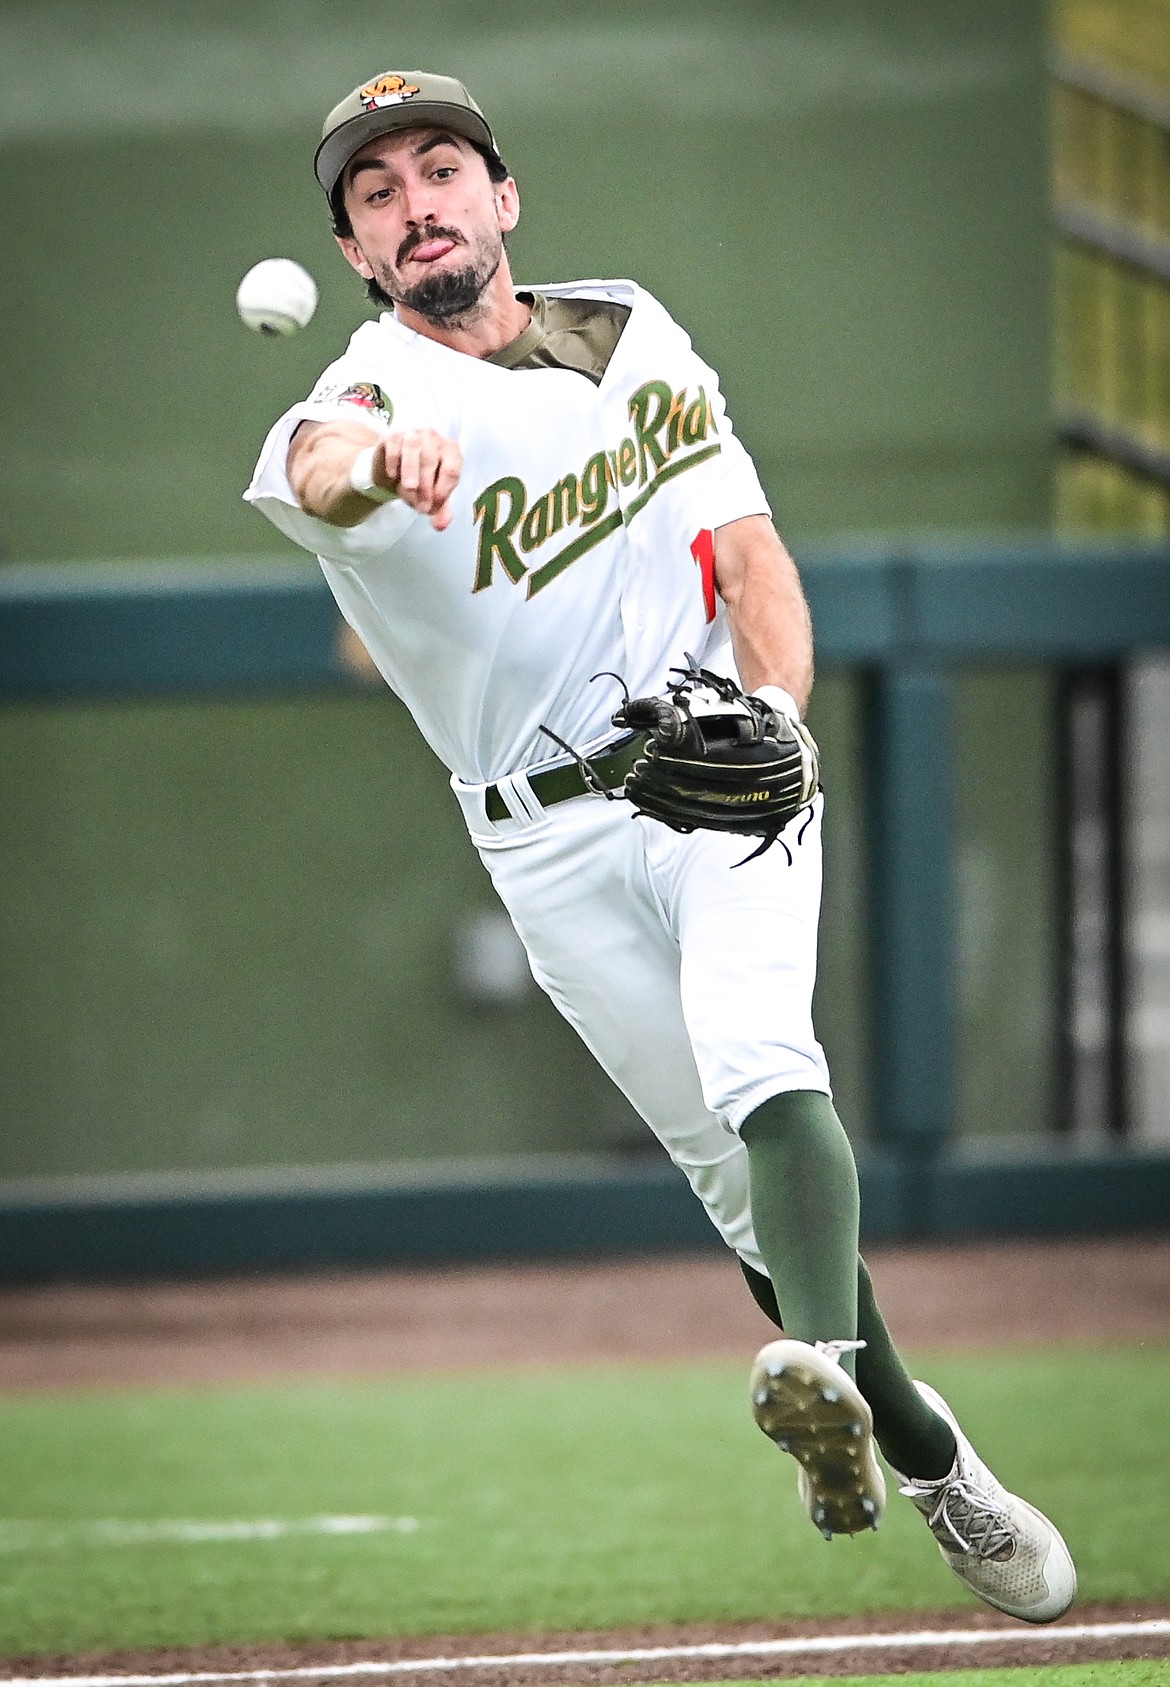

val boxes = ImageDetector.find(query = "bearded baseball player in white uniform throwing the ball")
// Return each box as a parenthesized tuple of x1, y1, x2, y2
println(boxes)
(244, 71, 1076, 1623)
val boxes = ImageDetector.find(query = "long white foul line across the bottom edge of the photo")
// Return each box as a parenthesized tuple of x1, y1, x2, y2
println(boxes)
(0, 1618, 1170, 1687)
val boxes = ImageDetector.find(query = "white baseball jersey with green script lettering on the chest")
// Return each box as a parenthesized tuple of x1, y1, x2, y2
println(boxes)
(244, 280, 769, 783)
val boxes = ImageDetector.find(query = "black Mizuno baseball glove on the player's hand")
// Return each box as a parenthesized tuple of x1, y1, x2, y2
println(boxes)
(614, 658, 819, 860)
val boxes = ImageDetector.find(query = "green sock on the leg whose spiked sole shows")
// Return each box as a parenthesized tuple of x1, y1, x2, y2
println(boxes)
(740, 1090, 858, 1375)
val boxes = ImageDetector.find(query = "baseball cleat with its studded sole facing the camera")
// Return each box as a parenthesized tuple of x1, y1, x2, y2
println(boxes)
(750, 1341, 885, 1540)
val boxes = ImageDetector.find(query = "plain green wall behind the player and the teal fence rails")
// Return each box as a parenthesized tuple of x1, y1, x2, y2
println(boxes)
(0, 0, 1049, 1178)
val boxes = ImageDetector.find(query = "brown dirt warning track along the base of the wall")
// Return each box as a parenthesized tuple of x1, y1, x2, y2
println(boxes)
(0, 1233, 1170, 1392)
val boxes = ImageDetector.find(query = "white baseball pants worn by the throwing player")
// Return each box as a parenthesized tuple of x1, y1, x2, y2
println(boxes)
(452, 779, 831, 1275)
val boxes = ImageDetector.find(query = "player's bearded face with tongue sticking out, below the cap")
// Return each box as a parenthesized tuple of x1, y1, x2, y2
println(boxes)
(337, 130, 519, 322)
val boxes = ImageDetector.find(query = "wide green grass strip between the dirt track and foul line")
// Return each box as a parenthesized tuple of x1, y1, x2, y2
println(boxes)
(0, 1348, 1170, 1653)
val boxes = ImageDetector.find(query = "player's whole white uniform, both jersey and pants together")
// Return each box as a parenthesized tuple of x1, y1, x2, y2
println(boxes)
(246, 280, 829, 1272)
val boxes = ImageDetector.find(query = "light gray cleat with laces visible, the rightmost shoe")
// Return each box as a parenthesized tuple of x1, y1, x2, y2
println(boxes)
(895, 1382, 1077, 1623)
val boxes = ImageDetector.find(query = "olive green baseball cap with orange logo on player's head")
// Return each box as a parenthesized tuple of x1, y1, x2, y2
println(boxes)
(314, 71, 499, 196)
